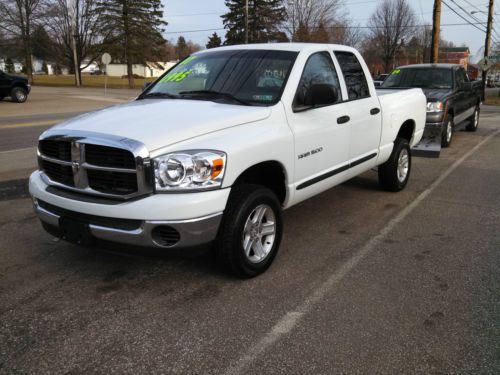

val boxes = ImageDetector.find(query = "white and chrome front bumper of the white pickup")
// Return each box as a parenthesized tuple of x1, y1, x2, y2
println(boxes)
(30, 171, 230, 248)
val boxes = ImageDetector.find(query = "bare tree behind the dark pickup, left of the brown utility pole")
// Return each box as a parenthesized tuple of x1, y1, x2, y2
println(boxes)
(368, 0, 416, 71)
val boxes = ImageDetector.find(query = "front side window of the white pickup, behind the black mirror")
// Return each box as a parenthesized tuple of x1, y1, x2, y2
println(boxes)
(293, 52, 342, 107)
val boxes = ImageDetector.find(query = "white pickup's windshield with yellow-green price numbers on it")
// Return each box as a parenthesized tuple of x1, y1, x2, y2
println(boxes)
(141, 50, 297, 105)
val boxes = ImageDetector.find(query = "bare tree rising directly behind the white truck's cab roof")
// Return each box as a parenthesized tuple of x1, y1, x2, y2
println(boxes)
(283, 0, 341, 42)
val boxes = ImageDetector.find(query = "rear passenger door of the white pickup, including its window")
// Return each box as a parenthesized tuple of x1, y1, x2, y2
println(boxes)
(335, 51, 382, 164)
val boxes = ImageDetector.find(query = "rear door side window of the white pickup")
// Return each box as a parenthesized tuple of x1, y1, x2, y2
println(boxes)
(335, 52, 370, 100)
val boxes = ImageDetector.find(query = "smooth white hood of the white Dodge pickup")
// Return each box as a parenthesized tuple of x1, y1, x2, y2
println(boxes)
(53, 99, 271, 151)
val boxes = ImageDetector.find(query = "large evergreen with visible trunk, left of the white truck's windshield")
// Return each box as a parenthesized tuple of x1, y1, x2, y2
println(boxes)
(97, 0, 167, 88)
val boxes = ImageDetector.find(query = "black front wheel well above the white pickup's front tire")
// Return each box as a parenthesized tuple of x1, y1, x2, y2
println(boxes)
(233, 161, 286, 204)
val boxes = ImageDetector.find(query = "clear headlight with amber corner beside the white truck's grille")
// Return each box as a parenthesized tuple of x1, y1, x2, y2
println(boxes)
(153, 150, 226, 192)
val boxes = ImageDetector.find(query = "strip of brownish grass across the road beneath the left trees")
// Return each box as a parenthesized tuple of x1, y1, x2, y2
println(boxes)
(33, 74, 154, 89)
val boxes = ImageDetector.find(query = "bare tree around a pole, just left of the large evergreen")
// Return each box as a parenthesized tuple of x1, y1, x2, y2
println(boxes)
(45, 0, 101, 82)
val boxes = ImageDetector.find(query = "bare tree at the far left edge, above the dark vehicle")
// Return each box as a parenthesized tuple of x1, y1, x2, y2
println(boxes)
(0, 0, 43, 82)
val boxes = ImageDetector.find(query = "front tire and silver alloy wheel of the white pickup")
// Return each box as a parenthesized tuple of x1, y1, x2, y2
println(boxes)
(214, 185, 283, 278)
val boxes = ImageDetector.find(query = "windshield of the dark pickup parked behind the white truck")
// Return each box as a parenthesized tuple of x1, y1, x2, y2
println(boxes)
(381, 68, 453, 89)
